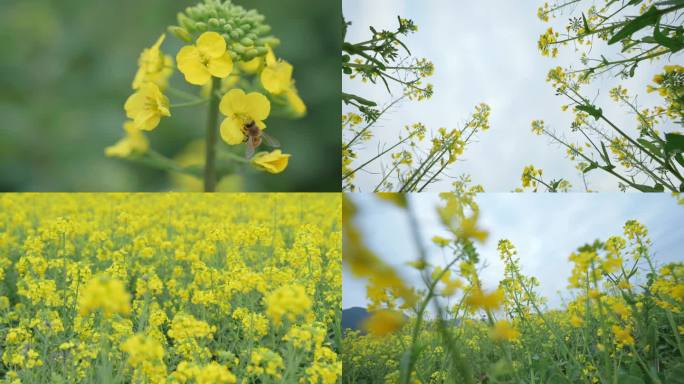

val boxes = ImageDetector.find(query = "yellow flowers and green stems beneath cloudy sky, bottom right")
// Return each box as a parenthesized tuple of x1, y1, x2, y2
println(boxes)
(342, 195, 684, 384)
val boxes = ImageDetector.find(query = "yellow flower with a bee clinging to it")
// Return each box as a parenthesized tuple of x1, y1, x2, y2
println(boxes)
(219, 89, 271, 145)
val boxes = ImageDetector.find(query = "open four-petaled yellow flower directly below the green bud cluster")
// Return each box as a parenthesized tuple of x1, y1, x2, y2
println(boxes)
(176, 32, 233, 85)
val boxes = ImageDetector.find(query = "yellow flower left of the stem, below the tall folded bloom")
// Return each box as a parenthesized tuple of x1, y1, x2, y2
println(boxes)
(124, 83, 171, 131)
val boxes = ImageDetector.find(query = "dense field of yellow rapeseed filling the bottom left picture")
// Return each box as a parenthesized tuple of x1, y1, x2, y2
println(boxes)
(0, 194, 342, 384)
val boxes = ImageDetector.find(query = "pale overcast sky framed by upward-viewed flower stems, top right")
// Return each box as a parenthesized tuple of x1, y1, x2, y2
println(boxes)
(343, 0, 663, 192)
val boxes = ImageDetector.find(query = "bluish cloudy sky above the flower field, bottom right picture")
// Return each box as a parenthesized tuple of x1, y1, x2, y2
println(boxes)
(342, 193, 684, 308)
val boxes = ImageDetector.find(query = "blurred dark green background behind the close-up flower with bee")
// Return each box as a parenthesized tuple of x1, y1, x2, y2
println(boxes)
(0, 0, 341, 191)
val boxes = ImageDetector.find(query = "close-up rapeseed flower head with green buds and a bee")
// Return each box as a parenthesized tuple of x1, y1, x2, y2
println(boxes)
(105, 0, 307, 183)
